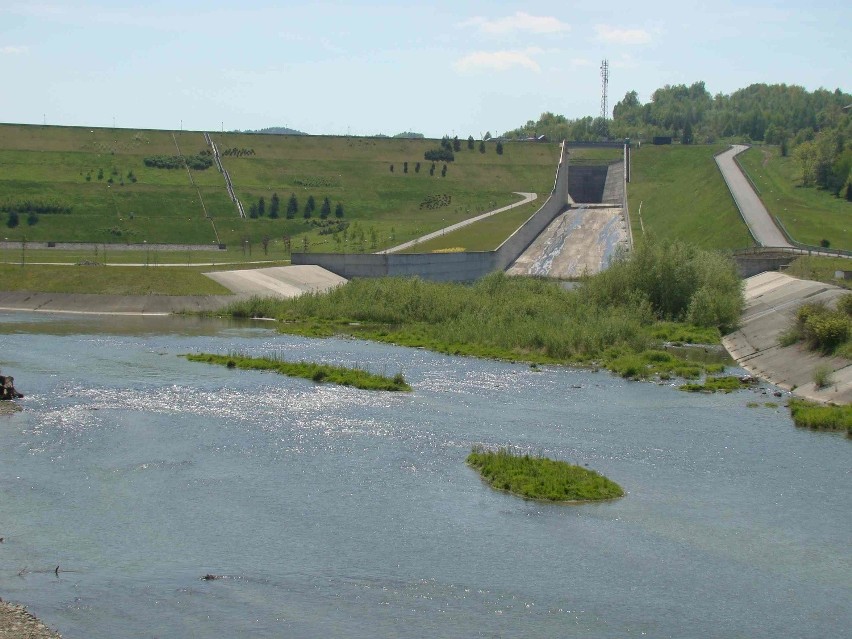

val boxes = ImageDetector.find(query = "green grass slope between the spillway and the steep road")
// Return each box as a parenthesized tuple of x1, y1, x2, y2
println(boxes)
(627, 145, 753, 249)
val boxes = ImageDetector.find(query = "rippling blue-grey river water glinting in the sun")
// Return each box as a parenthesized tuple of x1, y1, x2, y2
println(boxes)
(0, 314, 852, 639)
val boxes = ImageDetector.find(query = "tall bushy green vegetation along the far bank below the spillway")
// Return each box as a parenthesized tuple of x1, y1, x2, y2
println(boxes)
(227, 240, 743, 378)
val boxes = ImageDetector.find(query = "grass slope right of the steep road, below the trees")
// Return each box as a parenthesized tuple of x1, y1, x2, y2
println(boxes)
(738, 146, 852, 250)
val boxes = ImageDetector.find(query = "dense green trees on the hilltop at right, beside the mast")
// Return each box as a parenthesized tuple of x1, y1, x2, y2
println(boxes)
(505, 82, 852, 199)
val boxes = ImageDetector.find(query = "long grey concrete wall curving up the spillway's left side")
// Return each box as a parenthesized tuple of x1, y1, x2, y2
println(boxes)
(292, 148, 572, 282)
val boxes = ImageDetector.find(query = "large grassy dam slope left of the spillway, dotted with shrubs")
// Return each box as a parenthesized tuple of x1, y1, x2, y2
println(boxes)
(0, 125, 559, 250)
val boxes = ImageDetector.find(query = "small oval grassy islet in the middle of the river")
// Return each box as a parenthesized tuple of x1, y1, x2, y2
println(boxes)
(466, 446, 624, 502)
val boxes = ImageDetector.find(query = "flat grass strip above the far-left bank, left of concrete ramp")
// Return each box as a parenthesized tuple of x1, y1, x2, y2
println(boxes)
(0, 264, 231, 295)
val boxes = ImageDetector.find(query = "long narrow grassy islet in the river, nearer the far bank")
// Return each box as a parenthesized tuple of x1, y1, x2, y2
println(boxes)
(184, 353, 411, 391)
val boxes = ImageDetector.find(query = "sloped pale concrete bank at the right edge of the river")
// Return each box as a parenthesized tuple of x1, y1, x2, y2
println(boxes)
(722, 273, 852, 404)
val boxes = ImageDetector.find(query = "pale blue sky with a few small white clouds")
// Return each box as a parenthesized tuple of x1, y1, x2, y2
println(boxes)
(0, 0, 852, 138)
